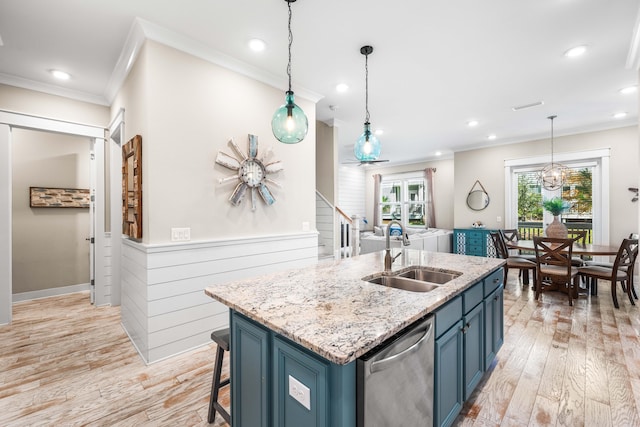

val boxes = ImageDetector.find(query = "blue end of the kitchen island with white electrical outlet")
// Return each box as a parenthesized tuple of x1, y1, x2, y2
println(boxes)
(231, 310, 356, 427)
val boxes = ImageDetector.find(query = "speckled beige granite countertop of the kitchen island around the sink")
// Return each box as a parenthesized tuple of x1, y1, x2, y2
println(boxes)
(205, 249, 505, 365)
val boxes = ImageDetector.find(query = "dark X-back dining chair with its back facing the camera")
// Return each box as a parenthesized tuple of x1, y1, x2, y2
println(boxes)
(533, 237, 579, 305)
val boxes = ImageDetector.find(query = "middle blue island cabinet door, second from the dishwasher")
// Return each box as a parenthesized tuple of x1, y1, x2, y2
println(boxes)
(463, 303, 484, 400)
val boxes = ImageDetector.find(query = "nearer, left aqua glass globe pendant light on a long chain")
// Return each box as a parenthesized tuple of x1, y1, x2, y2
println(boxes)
(271, 0, 309, 144)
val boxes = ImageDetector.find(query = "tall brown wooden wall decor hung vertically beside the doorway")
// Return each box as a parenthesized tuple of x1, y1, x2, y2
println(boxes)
(122, 135, 142, 240)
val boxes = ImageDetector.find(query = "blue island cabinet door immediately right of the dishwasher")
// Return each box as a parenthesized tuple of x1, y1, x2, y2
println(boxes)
(433, 320, 463, 426)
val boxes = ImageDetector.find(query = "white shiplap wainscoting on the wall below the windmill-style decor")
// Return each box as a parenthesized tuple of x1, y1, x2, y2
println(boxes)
(121, 231, 318, 363)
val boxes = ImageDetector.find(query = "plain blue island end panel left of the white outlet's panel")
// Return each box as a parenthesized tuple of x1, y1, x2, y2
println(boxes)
(231, 314, 271, 427)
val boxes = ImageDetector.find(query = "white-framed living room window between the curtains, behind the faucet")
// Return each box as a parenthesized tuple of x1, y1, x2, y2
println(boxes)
(378, 173, 427, 228)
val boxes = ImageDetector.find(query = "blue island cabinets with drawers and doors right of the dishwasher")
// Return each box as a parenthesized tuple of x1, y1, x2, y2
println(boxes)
(433, 269, 504, 426)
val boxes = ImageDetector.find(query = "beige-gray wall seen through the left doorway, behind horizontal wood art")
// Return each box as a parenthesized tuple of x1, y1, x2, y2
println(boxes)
(12, 129, 90, 294)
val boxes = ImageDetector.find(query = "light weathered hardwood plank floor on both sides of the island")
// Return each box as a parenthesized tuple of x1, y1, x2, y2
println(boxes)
(0, 271, 640, 427)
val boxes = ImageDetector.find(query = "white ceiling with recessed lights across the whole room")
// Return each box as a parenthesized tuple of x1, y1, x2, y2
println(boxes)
(0, 0, 640, 163)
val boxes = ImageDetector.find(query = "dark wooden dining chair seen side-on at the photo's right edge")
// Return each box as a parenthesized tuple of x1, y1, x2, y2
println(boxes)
(578, 239, 638, 308)
